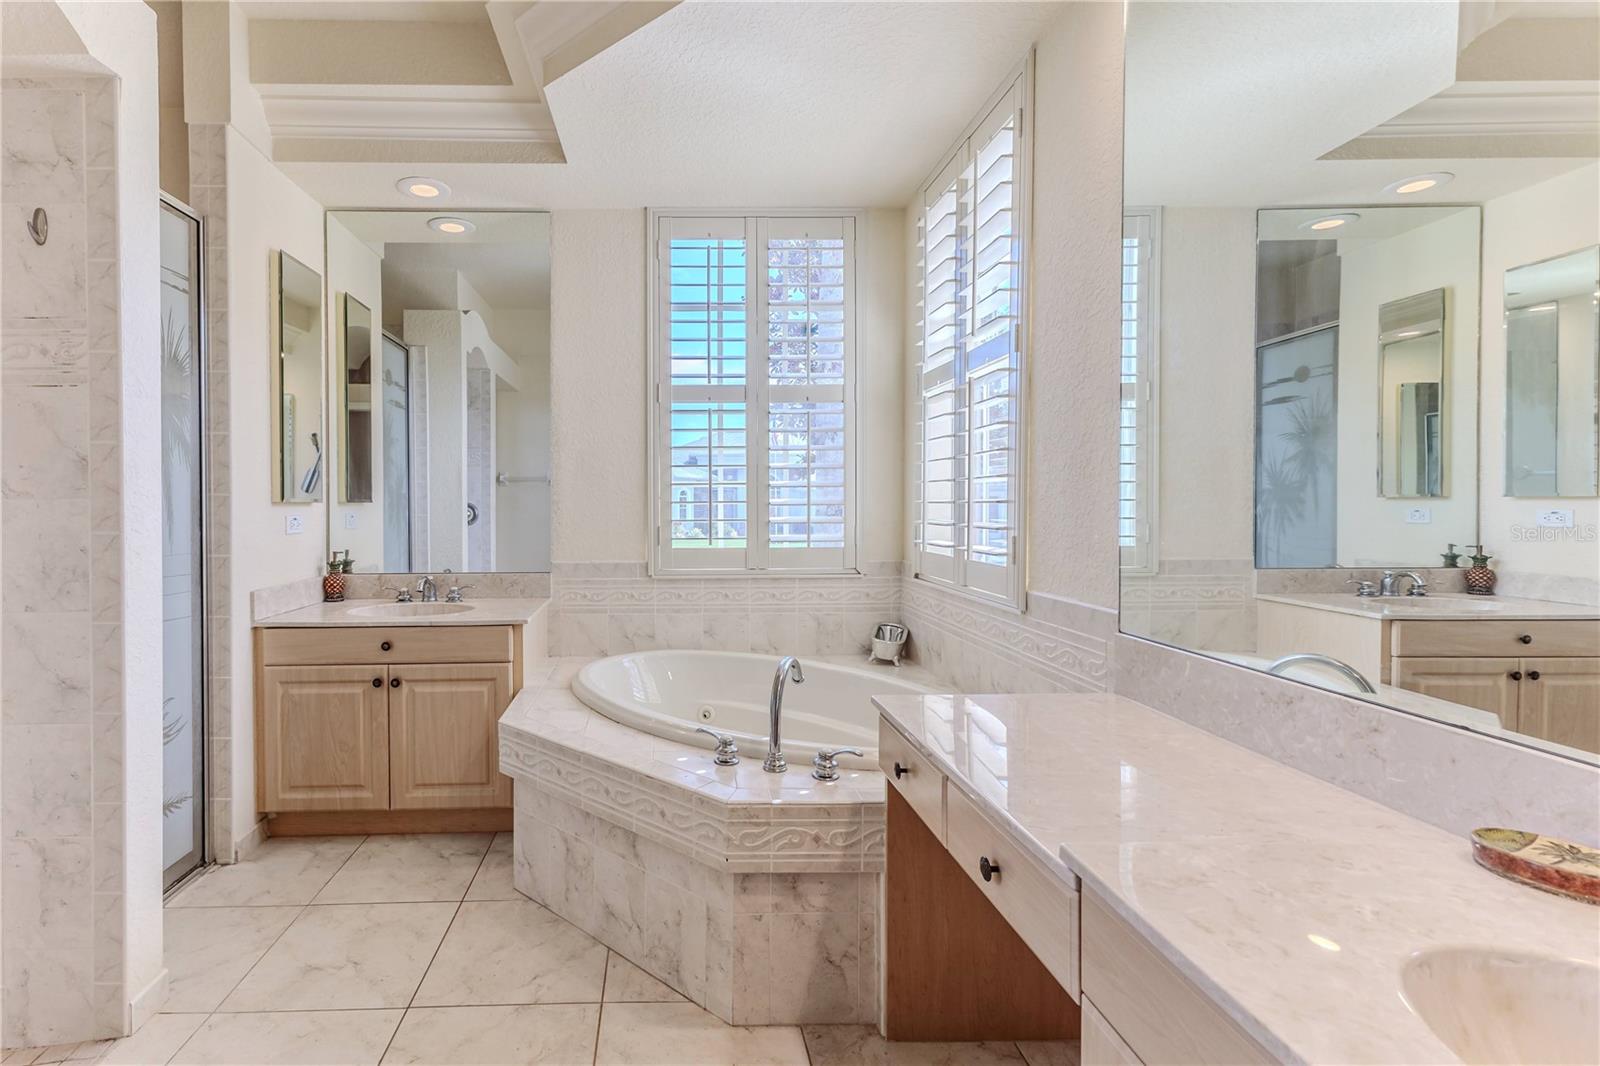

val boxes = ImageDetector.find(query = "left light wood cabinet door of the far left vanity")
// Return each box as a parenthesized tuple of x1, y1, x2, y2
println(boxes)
(258, 666, 389, 812)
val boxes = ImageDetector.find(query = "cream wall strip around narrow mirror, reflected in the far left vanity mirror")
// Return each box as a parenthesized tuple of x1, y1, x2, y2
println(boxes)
(323, 214, 384, 573)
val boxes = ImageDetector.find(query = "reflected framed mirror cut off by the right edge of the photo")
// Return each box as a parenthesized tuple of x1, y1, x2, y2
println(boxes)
(1506, 246, 1600, 496)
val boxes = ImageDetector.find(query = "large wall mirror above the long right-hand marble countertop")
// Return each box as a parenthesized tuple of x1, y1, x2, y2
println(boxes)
(1117, 0, 1600, 762)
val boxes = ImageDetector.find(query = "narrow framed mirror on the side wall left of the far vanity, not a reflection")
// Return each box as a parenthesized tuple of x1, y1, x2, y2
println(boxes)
(270, 251, 323, 503)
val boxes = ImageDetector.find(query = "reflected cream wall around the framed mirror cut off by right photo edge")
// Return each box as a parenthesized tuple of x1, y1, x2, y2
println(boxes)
(1480, 163, 1600, 602)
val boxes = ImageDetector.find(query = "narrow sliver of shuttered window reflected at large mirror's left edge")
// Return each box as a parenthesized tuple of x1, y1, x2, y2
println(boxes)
(1117, 208, 1162, 573)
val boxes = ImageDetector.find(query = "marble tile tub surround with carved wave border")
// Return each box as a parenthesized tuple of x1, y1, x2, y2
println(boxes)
(501, 658, 928, 1024)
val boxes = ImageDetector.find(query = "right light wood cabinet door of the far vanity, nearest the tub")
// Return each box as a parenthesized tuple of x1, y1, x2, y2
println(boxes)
(389, 663, 510, 810)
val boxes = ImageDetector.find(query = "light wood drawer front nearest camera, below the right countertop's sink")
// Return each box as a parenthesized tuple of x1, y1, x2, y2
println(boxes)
(1083, 892, 1274, 1066)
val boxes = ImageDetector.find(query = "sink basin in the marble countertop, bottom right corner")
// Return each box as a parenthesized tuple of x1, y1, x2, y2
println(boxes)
(1400, 948, 1600, 1063)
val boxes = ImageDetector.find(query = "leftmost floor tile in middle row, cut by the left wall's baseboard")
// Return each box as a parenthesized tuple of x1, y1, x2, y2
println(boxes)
(162, 908, 301, 1013)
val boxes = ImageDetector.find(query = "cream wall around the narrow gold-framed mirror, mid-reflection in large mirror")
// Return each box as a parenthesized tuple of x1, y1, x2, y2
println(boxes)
(1338, 210, 1478, 567)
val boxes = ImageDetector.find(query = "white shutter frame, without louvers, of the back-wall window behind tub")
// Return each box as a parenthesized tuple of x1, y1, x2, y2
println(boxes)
(645, 208, 867, 578)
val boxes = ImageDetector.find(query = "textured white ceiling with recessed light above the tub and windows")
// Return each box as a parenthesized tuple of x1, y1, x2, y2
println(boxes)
(283, 0, 1061, 208)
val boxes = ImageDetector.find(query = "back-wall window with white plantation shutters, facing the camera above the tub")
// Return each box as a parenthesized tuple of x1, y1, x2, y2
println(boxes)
(653, 213, 856, 573)
